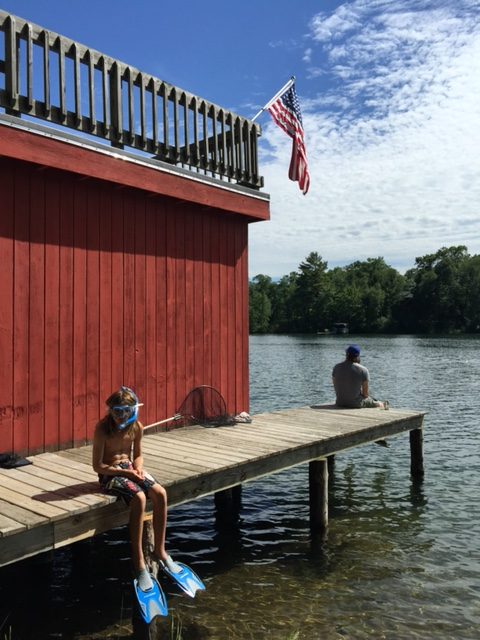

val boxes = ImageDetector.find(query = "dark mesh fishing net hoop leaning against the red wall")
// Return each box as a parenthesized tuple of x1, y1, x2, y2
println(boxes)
(178, 385, 235, 427)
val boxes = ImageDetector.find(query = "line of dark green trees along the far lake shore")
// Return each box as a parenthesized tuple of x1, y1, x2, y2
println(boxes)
(249, 246, 480, 333)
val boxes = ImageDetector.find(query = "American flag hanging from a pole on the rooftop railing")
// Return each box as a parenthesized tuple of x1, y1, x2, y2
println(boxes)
(268, 84, 310, 195)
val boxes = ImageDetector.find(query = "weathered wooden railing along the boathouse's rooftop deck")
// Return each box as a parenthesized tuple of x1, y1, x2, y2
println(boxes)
(0, 10, 263, 189)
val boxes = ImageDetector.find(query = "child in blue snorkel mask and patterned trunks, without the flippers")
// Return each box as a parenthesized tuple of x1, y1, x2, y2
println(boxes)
(92, 387, 181, 591)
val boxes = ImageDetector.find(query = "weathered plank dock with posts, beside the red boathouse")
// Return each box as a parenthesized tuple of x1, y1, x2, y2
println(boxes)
(0, 405, 424, 566)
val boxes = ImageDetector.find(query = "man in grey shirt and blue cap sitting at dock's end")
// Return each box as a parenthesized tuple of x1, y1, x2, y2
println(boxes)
(332, 344, 388, 409)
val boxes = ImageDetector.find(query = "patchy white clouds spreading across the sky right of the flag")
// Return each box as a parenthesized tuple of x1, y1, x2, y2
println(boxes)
(250, 0, 480, 276)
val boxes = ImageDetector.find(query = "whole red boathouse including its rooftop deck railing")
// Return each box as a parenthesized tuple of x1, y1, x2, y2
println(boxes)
(0, 10, 269, 455)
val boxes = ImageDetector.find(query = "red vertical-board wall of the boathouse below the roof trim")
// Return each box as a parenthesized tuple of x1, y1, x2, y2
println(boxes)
(0, 157, 253, 454)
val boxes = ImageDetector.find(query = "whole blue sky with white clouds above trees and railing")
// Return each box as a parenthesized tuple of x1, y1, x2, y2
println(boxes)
(0, 0, 480, 277)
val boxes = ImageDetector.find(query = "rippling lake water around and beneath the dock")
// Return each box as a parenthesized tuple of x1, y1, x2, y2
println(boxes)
(0, 336, 480, 640)
